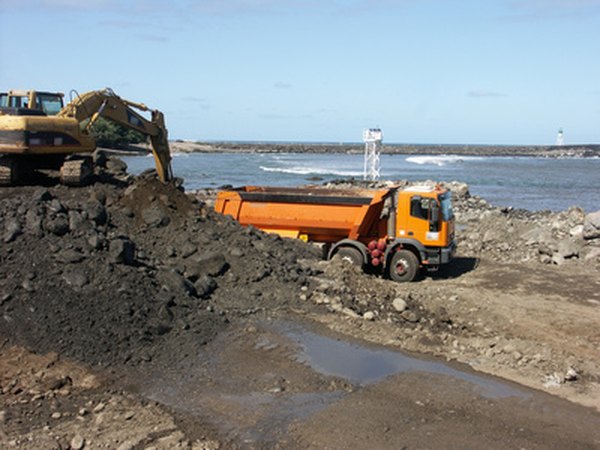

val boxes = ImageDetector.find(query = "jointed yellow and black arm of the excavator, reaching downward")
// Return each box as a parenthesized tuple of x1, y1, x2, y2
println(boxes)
(57, 88, 173, 182)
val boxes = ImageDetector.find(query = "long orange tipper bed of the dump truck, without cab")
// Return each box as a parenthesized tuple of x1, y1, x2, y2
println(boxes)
(215, 186, 395, 242)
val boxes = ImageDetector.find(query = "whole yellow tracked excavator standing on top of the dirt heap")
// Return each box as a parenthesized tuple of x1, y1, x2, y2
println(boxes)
(0, 88, 173, 186)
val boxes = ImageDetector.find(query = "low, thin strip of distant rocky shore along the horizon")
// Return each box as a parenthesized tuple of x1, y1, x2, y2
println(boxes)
(126, 140, 600, 158)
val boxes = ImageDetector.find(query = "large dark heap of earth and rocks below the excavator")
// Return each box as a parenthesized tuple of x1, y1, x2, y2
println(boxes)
(0, 157, 315, 365)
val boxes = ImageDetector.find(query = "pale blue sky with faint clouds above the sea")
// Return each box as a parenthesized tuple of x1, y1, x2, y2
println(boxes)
(0, 0, 600, 145)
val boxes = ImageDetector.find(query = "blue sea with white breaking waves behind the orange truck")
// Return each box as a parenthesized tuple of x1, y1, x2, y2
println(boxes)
(123, 153, 600, 212)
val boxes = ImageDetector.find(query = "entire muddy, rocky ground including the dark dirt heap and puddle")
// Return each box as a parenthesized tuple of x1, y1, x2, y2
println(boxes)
(0, 159, 600, 449)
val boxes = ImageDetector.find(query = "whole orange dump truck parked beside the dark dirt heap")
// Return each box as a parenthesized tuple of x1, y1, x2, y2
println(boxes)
(215, 186, 456, 281)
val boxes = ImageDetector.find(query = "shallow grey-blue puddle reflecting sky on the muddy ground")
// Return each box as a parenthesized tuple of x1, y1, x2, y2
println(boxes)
(281, 325, 529, 398)
